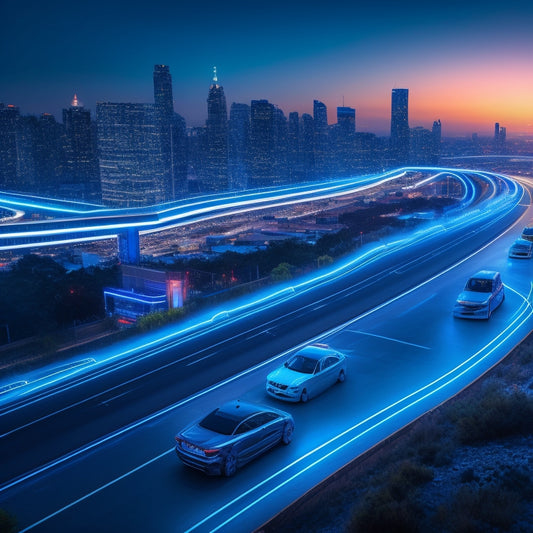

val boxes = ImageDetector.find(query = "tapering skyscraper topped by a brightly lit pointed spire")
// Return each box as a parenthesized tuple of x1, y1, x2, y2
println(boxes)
(203, 67, 228, 191)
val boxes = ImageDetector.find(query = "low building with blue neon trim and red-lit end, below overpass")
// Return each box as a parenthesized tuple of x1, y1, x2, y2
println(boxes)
(104, 265, 187, 327)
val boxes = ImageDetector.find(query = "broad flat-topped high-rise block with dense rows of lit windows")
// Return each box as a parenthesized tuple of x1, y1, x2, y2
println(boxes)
(96, 102, 167, 207)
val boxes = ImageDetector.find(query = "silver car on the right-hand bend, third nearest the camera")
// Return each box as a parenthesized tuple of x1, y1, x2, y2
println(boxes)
(453, 270, 505, 319)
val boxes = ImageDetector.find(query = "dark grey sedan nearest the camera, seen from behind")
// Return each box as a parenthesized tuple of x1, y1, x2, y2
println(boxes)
(175, 400, 294, 477)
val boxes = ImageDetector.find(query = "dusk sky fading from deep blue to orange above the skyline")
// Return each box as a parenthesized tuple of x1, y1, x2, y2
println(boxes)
(0, 0, 533, 137)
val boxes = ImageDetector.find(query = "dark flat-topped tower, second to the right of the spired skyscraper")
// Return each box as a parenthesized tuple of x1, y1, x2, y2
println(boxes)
(248, 100, 276, 188)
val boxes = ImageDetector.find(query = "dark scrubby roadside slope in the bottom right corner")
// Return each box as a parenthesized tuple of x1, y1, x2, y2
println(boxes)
(261, 335, 533, 533)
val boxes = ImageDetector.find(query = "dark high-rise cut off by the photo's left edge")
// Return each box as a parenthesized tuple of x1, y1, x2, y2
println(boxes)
(0, 103, 20, 190)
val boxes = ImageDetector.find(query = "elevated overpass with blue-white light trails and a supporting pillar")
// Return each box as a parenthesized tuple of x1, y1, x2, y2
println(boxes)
(0, 167, 509, 264)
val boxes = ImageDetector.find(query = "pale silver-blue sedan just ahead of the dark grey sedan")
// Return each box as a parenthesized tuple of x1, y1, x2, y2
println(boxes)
(266, 344, 346, 402)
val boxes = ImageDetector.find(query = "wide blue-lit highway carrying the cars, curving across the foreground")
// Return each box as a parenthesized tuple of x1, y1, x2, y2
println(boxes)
(0, 168, 532, 532)
